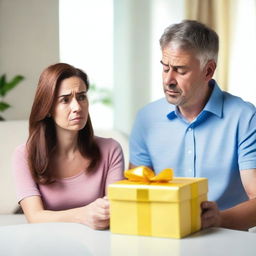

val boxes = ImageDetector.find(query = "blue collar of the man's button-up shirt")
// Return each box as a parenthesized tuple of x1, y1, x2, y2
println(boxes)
(167, 79, 223, 120)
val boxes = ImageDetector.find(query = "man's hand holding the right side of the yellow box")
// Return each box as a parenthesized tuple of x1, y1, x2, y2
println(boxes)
(201, 201, 221, 229)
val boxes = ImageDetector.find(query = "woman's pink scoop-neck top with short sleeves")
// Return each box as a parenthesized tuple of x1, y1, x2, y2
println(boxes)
(13, 137, 124, 211)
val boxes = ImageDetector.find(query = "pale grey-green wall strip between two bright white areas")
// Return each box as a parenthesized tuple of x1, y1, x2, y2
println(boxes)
(114, 0, 151, 134)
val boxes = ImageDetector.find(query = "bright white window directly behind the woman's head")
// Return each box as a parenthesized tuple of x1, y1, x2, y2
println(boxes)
(59, 0, 113, 129)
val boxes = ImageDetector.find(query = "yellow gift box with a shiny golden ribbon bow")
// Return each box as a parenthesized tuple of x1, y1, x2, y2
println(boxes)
(108, 166, 208, 238)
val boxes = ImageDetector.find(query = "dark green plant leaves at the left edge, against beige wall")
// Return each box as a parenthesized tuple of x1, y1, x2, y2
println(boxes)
(0, 74, 24, 121)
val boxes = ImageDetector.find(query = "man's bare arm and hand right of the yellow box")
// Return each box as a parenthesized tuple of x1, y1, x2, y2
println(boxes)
(202, 169, 256, 230)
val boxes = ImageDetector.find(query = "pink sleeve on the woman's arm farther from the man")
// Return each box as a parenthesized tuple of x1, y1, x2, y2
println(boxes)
(12, 145, 40, 202)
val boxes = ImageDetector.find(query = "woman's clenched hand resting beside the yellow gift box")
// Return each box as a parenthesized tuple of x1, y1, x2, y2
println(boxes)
(84, 197, 109, 229)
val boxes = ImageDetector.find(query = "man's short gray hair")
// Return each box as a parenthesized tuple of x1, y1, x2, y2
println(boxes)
(160, 20, 219, 68)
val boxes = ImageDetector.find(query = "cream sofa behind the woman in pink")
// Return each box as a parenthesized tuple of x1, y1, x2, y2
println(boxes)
(0, 120, 128, 219)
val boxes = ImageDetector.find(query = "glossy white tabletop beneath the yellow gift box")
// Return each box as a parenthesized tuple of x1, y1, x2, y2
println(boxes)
(0, 223, 256, 256)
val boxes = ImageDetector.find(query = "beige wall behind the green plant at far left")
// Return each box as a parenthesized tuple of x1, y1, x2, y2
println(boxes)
(0, 0, 59, 120)
